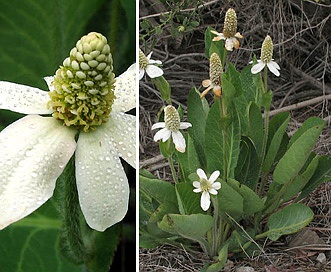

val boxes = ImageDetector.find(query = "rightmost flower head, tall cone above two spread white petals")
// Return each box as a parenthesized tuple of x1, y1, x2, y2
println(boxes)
(251, 35, 280, 76)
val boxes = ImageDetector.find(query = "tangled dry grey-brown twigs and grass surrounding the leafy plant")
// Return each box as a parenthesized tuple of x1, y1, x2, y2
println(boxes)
(139, 0, 331, 272)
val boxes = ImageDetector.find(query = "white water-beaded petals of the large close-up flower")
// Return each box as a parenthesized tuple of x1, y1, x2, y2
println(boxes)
(0, 31, 136, 231)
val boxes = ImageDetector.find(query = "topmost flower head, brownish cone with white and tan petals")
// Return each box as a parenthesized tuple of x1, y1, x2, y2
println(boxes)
(210, 8, 243, 51)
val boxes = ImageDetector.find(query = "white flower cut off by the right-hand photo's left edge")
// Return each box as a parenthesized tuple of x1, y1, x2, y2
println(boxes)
(139, 49, 163, 80)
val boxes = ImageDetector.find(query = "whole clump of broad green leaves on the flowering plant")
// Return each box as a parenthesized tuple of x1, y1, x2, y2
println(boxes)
(139, 9, 331, 272)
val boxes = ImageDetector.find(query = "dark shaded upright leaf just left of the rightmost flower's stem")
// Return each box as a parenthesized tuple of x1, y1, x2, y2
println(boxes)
(235, 136, 260, 190)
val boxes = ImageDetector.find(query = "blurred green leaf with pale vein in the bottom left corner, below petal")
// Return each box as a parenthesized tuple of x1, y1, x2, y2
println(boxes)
(0, 200, 82, 272)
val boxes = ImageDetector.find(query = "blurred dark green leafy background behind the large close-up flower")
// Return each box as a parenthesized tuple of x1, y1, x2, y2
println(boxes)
(0, 0, 136, 272)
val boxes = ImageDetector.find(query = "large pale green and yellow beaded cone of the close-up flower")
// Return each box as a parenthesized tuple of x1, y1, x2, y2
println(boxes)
(49, 32, 115, 132)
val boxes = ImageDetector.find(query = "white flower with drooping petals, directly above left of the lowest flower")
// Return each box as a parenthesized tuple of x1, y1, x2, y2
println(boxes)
(152, 105, 192, 153)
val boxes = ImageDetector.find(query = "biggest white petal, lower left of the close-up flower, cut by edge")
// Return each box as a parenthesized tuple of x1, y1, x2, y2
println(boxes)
(0, 115, 76, 229)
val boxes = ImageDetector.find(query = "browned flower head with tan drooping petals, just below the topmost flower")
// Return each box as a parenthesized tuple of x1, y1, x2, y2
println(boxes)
(200, 53, 223, 98)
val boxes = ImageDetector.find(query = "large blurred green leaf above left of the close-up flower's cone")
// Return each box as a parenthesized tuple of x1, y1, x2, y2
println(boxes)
(0, 0, 104, 89)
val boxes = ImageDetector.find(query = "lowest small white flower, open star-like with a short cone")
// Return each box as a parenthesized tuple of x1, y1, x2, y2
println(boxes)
(193, 168, 221, 211)
